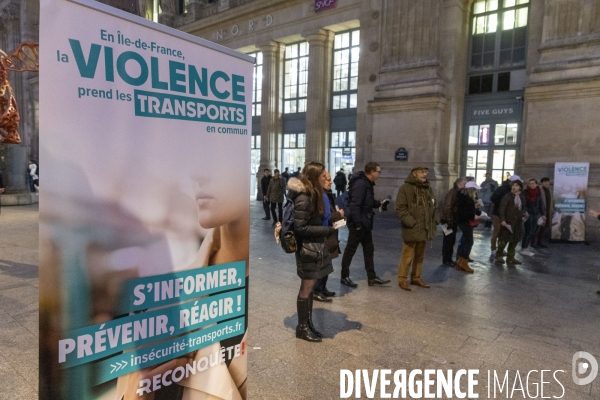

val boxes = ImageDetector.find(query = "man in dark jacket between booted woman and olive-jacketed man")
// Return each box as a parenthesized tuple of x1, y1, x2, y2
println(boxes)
(341, 162, 391, 288)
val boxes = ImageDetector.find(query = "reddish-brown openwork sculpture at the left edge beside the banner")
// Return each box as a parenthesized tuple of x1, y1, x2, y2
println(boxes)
(0, 43, 40, 143)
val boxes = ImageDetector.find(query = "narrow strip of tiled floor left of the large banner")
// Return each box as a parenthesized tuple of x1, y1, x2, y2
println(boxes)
(0, 204, 39, 400)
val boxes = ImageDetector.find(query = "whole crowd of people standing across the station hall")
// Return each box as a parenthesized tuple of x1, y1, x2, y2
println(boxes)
(261, 162, 600, 342)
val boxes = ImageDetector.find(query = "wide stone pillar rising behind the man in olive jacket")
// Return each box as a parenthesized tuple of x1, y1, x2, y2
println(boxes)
(368, 0, 448, 198)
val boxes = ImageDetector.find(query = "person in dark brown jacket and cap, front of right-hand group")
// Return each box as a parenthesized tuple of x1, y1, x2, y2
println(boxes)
(495, 180, 528, 265)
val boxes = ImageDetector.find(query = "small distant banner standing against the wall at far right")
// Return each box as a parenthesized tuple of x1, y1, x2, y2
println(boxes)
(552, 162, 590, 242)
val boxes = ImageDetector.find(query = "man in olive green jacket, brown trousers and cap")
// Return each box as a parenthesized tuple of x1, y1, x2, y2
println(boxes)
(396, 167, 440, 290)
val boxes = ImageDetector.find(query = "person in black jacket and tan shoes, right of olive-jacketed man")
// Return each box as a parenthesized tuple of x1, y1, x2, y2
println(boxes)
(456, 181, 481, 274)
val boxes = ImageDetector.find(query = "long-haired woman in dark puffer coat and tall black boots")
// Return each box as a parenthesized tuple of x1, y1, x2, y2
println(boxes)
(287, 162, 335, 342)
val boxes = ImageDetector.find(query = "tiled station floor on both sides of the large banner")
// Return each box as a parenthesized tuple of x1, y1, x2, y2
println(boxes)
(0, 202, 600, 400)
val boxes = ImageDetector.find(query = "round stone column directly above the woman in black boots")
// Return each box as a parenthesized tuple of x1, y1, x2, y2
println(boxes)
(303, 29, 334, 167)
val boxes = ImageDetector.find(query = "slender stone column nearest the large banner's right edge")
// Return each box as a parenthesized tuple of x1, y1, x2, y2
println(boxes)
(256, 41, 285, 200)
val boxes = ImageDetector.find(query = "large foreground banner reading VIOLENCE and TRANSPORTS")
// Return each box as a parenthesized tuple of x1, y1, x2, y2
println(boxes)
(40, 0, 253, 400)
